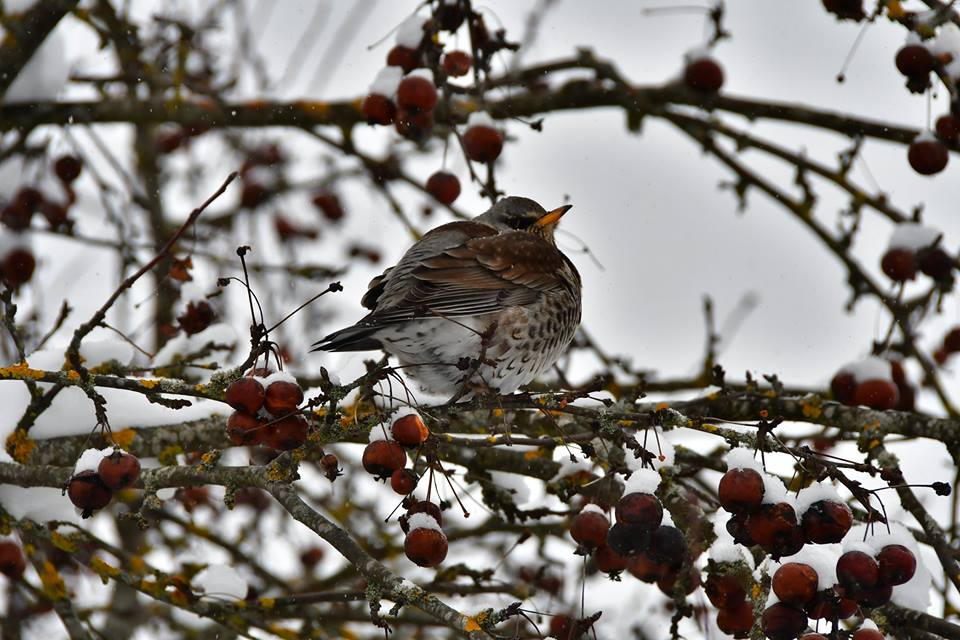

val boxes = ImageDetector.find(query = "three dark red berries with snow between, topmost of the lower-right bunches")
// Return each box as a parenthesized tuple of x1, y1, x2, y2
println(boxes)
(717, 467, 853, 560)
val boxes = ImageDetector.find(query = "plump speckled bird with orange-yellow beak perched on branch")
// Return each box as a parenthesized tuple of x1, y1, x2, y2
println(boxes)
(314, 196, 580, 397)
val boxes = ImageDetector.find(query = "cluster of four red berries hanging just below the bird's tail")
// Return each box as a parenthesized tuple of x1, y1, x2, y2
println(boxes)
(226, 370, 308, 451)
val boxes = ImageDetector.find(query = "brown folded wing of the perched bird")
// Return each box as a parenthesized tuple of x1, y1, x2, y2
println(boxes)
(361, 228, 567, 326)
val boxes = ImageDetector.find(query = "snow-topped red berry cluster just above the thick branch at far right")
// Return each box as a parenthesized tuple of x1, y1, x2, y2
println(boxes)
(830, 357, 916, 411)
